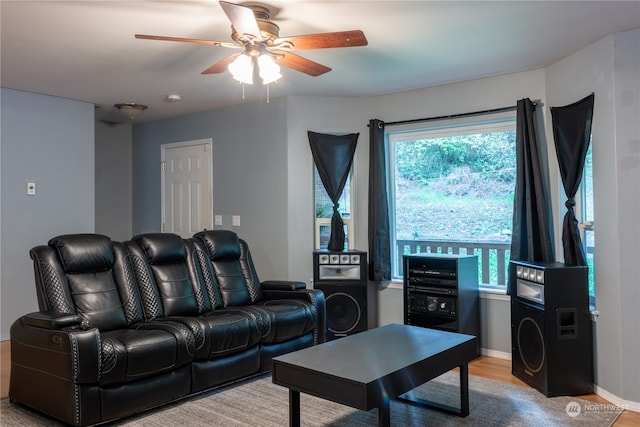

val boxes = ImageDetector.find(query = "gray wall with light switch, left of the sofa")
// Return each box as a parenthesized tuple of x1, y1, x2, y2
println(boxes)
(0, 88, 95, 340)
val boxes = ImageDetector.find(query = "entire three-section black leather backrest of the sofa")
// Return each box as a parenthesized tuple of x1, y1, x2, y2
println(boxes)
(30, 230, 263, 331)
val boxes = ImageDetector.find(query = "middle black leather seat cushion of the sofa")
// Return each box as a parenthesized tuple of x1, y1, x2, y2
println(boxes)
(182, 309, 260, 360)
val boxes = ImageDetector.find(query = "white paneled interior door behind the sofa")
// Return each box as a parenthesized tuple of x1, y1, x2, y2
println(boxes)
(162, 139, 213, 238)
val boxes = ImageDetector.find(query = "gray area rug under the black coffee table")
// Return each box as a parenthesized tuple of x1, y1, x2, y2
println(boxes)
(0, 371, 622, 427)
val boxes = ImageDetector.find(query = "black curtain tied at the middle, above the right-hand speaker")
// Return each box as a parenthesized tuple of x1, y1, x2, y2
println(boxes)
(551, 94, 594, 265)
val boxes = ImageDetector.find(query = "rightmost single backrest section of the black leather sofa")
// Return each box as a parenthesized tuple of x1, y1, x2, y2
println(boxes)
(193, 230, 263, 307)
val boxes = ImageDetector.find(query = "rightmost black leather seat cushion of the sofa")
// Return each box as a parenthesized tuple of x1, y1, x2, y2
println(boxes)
(234, 299, 316, 344)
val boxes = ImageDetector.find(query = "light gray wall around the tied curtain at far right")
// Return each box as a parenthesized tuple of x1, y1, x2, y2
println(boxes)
(547, 30, 640, 410)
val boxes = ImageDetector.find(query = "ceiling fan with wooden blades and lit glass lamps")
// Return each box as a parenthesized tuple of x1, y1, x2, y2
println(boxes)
(135, 1, 367, 83)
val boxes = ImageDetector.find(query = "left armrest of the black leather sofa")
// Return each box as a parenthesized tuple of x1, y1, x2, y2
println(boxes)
(11, 312, 101, 384)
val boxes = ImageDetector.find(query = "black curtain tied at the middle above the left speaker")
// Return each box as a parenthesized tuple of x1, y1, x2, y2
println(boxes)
(307, 131, 359, 251)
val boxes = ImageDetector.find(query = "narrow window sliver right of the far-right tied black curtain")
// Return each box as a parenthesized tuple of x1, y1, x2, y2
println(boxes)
(576, 143, 596, 306)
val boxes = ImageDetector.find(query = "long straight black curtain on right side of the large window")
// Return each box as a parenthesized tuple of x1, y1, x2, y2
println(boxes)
(508, 98, 555, 295)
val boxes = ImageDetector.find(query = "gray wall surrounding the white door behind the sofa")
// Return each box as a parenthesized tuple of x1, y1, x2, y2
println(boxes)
(133, 99, 289, 280)
